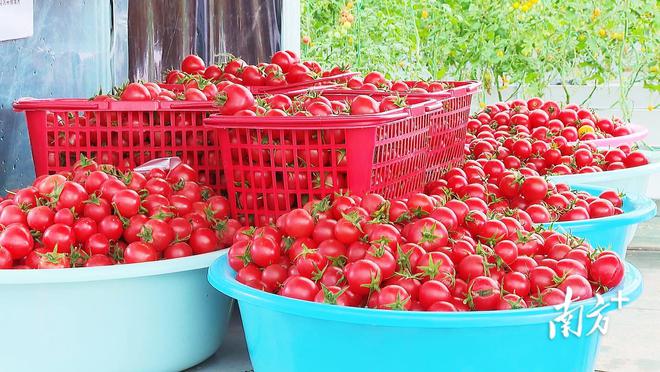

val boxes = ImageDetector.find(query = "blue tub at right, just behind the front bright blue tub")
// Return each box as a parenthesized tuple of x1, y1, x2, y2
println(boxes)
(542, 185, 656, 258)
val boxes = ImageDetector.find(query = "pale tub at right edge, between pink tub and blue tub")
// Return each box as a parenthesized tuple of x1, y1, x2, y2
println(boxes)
(548, 151, 660, 196)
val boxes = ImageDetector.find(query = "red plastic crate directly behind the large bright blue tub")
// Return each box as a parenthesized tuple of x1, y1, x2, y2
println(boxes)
(204, 97, 434, 225)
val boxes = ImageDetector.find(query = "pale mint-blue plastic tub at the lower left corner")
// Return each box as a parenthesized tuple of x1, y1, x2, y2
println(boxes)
(0, 250, 233, 372)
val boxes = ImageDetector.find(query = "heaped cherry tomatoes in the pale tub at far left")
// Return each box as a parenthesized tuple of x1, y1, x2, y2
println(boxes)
(0, 157, 241, 269)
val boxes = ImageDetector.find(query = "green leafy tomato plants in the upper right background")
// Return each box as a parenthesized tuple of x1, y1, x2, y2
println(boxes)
(301, 0, 660, 113)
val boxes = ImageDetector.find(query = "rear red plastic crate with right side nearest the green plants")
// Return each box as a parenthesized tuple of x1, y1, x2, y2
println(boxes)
(314, 81, 481, 182)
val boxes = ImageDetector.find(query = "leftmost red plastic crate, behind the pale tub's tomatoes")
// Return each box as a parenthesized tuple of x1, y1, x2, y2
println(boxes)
(14, 98, 225, 191)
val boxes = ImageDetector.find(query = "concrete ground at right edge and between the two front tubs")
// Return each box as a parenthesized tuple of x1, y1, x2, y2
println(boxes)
(190, 217, 660, 372)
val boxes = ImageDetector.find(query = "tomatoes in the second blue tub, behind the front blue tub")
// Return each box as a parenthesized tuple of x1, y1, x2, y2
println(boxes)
(425, 159, 624, 226)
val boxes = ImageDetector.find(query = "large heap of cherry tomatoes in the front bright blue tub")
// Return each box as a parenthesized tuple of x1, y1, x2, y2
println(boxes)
(228, 193, 624, 311)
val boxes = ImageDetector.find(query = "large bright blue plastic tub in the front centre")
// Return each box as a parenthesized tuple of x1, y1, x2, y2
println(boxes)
(209, 257, 642, 372)
